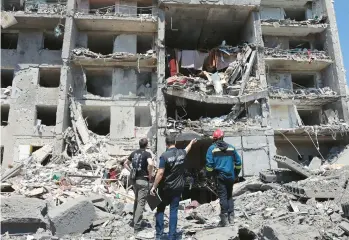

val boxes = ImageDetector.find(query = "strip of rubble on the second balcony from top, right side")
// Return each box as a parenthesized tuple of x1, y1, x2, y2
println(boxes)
(264, 47, 331, 62)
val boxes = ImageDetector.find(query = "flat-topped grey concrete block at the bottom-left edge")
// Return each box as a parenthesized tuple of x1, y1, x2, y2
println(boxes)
(0, 196, 47, 234)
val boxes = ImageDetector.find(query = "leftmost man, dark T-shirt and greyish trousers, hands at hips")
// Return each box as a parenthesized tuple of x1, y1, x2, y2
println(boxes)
(124, 138, 154, 233)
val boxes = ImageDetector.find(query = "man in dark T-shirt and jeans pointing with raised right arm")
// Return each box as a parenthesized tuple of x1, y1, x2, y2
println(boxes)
(150, 135, 196, 240)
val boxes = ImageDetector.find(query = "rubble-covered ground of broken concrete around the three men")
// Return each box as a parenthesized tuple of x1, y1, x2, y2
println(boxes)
(1, 98, 349, 240)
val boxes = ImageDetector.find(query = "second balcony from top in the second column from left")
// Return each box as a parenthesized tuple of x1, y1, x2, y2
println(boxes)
(72, 32, 157, 68)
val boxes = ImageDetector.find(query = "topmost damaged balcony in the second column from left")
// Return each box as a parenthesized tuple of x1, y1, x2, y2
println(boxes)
(74, 0, 157, 33)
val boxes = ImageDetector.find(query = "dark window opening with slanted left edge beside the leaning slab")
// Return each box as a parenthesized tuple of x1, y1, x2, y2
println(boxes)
(82, 106, 110, 136)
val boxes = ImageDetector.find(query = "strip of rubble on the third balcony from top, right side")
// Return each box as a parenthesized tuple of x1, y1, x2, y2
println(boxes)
(269, 86, 338, 99)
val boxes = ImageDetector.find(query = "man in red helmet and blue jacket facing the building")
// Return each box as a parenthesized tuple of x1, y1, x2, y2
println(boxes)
(206, 129, 242, 227)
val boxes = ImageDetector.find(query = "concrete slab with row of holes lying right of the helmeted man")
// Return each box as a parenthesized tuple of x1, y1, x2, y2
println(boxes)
(259, 169, 304, 183)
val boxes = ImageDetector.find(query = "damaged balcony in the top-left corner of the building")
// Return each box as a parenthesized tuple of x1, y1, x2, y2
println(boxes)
(2, 0, 67, 29)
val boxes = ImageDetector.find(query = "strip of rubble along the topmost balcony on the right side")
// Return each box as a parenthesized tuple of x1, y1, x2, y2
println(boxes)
(261, 17, 328, 27)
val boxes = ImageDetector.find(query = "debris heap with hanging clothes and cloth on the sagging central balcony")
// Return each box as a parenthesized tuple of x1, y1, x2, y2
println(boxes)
(166, 43, 260, 96)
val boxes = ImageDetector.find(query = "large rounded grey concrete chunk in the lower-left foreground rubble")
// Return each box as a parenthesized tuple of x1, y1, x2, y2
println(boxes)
(48, 197, 96, 237)
